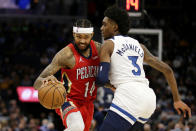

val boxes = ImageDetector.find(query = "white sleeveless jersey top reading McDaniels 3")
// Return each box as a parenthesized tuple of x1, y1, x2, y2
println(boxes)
(109, 35, 149, 86)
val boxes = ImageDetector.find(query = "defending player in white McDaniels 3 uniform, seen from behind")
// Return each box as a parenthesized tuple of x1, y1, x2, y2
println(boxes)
(96, 6, 191, 131)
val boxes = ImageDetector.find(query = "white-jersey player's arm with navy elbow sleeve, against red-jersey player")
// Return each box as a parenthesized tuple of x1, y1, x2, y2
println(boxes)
(96, 40, 114, 86)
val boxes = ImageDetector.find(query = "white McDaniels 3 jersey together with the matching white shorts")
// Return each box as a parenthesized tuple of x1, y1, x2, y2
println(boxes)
(109, 36, 156, 125)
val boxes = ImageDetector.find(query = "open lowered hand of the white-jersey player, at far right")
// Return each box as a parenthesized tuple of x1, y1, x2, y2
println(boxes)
(174, 101, 191, 118)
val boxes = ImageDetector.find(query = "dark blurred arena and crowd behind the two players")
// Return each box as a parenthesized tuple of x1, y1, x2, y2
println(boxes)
(0, 0, 196, 131)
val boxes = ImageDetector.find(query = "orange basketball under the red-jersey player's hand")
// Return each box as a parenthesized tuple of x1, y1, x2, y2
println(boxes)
(38, 81, 66, 109)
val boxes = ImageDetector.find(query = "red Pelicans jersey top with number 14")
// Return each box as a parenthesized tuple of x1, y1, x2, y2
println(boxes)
(61, 40, 100, 101)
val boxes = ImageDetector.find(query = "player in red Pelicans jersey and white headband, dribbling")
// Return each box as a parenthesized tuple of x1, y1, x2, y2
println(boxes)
(34, 19, 100, 131)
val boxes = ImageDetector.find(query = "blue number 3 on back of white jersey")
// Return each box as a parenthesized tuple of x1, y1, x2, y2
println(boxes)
(128, 56, 141, 76)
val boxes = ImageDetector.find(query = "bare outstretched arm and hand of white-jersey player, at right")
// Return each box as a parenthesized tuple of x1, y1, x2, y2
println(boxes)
(141, 44, 191, 117)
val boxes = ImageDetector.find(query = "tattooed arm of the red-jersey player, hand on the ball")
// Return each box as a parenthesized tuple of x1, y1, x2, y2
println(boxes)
(33, 47, 72, 89)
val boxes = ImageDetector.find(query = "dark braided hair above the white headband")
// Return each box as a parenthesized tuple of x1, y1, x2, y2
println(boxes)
(74, 19, 93, 28)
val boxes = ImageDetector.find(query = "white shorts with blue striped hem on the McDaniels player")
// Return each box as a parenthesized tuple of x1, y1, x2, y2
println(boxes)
(110, 82, 156, 125)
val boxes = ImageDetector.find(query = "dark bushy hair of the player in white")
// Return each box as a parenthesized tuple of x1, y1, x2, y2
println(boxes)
(104, 5, 130, 35)
